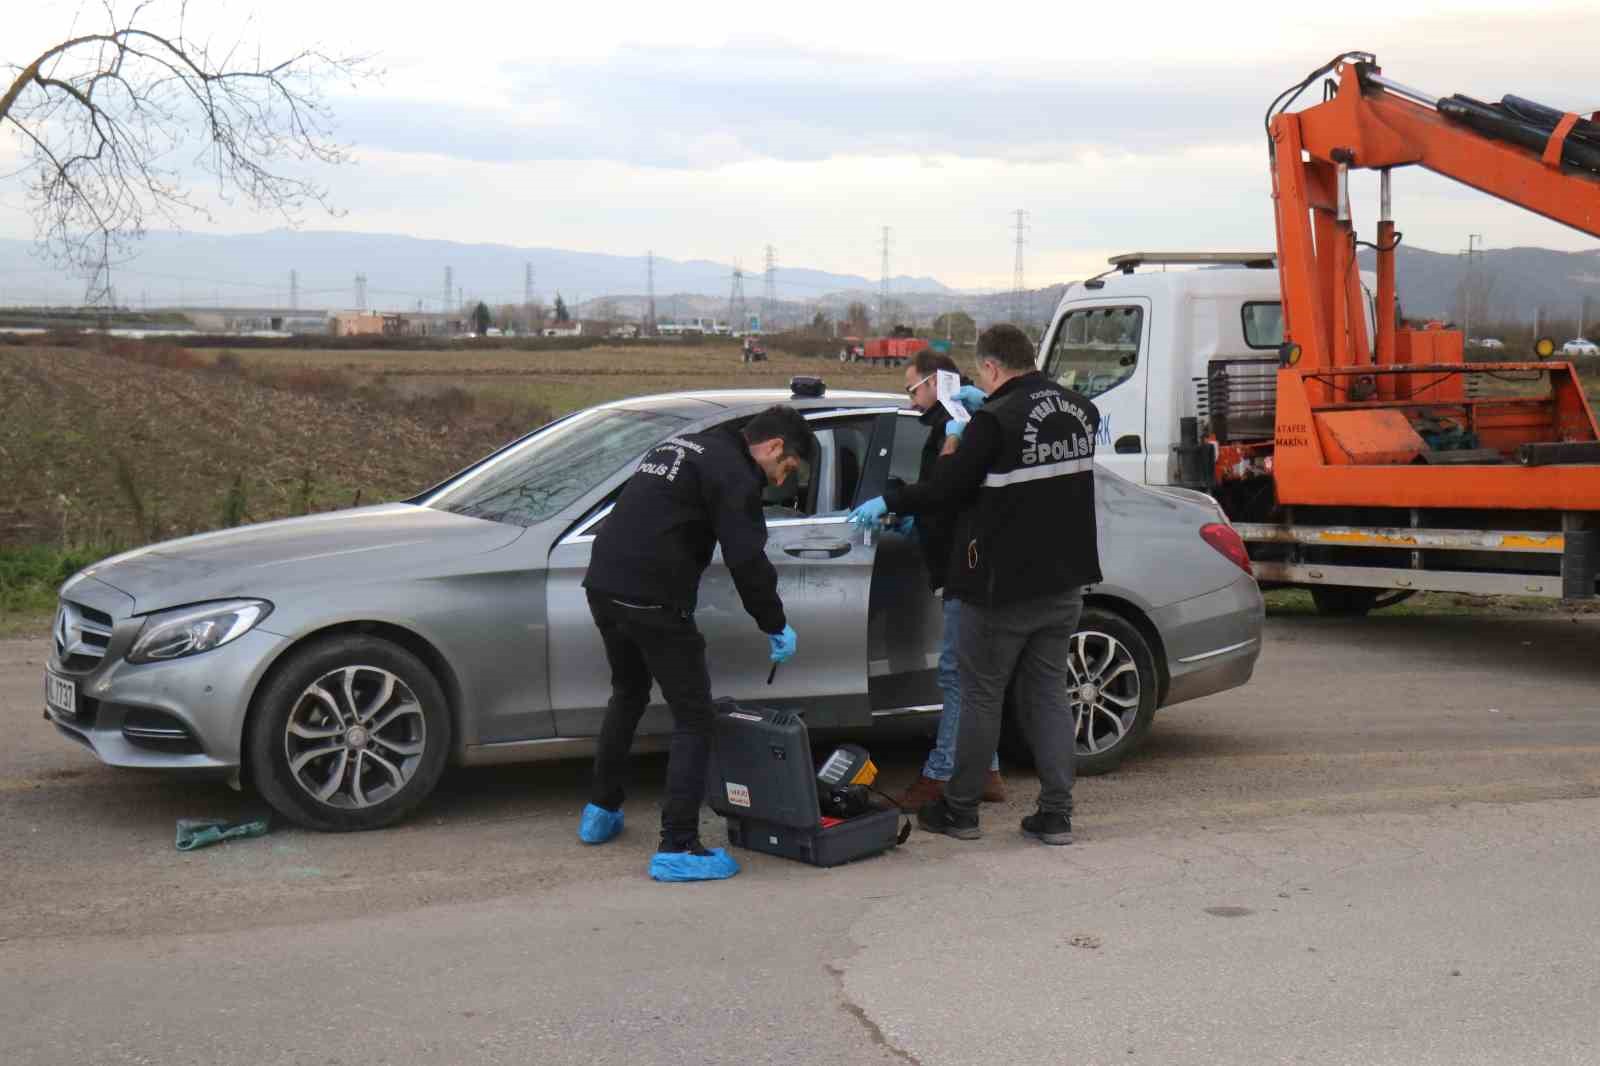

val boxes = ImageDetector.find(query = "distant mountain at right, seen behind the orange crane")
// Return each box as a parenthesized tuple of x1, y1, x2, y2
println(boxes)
(1360, 243, 1600, 321)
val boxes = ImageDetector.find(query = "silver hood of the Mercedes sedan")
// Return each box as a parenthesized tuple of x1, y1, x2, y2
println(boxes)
(62, 504, 523, 613)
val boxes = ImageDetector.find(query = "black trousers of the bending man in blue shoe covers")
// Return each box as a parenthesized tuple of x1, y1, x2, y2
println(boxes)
(589, 592, 712, 850)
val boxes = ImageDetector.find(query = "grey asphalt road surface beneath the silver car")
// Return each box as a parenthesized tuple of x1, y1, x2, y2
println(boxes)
(0, 618, 1600, 1066)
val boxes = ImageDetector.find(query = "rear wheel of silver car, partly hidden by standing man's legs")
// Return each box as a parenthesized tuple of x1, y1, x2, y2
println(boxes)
(1000, 607, 1160, 778)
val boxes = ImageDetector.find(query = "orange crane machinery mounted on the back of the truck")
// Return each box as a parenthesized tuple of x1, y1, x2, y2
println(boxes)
(1264, 53, 1600, 512)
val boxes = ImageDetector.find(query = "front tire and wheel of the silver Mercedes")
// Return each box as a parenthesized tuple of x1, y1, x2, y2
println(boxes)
(245, 635, 451, 832)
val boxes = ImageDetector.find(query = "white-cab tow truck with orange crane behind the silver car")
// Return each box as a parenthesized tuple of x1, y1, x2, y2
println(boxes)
(1040, 53, 1600, 613)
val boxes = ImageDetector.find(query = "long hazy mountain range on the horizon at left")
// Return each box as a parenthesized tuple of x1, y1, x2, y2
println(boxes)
(0, 229, 950, 311)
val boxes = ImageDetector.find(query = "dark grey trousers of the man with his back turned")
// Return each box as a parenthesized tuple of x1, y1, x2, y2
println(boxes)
(944, 592, 1083, 815)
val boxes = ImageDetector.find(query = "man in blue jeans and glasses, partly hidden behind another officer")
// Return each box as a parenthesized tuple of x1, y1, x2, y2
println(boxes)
(898, 347, 1005, 810)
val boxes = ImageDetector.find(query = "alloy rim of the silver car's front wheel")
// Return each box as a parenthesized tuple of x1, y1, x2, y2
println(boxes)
(283, 666, 427, 810)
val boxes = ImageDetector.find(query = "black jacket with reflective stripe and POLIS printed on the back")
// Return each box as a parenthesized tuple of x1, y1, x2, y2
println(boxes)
(883, 371, 1101, 607)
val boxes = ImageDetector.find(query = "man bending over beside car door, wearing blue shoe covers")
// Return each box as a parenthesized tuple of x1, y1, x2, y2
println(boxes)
(578, 407, 816, 880)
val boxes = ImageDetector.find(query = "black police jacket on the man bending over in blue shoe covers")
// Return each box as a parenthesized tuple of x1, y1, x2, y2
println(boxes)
(584, 429, 786, 634)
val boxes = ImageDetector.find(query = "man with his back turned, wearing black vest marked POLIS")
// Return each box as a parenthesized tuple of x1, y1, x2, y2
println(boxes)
(853, 325, 1101, 844)
